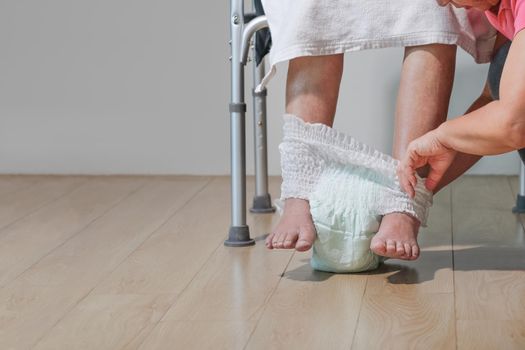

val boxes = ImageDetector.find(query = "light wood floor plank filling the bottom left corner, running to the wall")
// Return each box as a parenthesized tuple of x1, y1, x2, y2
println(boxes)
(0, 179, 207, 349)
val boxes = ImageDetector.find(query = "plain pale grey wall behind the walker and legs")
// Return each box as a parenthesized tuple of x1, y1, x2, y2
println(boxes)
(0, 0, 519, 174)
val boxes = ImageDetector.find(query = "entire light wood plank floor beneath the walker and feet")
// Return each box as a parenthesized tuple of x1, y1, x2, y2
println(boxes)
(0, 176, 525, 350)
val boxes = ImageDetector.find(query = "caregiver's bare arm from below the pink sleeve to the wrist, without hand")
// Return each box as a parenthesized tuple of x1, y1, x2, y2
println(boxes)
(436, 30, 525, 155)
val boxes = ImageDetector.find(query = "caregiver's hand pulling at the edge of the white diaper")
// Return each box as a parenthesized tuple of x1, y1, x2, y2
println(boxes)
(397, 128, 456, 198)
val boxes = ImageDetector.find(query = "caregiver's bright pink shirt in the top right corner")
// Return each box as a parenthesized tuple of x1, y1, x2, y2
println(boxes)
(485, 0, 525, 40)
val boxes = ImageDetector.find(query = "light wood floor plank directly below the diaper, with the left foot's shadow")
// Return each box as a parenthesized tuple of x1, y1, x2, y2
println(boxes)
(247, 252, 366, 349)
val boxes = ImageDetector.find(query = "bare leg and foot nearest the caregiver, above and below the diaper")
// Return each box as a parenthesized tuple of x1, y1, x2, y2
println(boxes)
(370, 44, 456, 260)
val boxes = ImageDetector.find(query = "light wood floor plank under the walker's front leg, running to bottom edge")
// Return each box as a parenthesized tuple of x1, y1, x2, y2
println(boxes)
(134, 179, 293, 349)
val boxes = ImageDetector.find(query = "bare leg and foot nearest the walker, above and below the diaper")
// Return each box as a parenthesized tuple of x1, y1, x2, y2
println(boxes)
(266, 54, 344, 251)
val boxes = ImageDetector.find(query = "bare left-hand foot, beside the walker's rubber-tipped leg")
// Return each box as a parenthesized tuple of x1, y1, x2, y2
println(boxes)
(266, 198, 316, 252)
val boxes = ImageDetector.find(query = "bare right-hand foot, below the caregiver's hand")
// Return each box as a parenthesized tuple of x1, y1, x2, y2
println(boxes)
(370, 213, 420, 260)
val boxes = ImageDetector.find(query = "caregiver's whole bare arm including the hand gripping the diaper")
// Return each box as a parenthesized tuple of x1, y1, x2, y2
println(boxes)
(398, 30, 525, 196)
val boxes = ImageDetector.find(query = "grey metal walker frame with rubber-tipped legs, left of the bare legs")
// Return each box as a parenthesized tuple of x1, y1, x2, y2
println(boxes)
(224, 0, 275, 247)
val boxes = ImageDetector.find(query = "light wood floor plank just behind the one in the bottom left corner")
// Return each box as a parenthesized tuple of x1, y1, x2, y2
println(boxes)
(0, 177, 144, 286)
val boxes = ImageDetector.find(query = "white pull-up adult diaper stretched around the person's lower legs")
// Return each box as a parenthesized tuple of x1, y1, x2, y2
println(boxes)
(279, 115, 432, 272)
